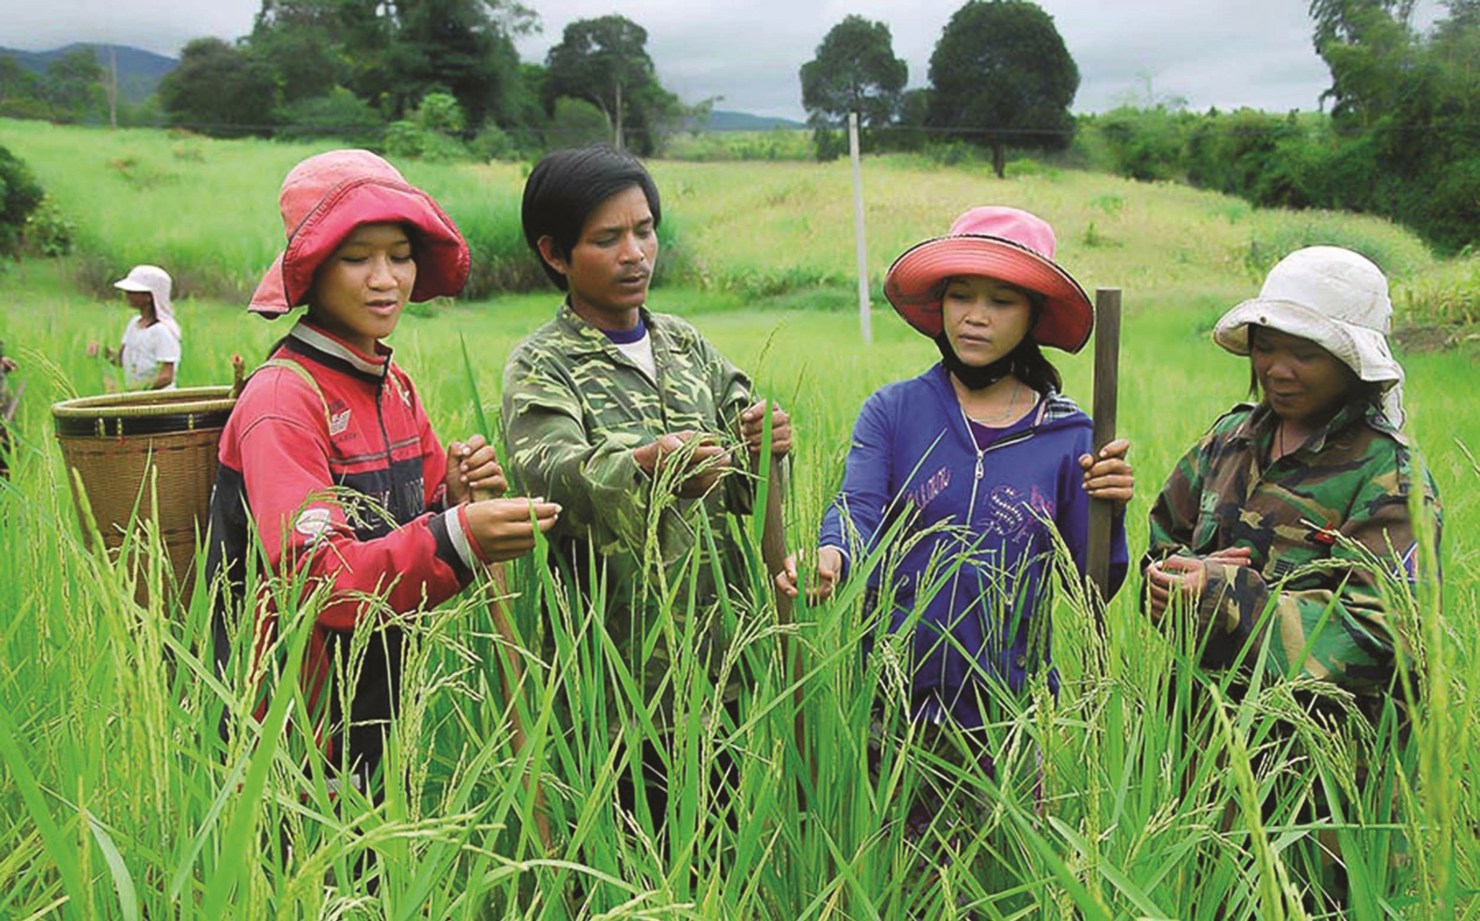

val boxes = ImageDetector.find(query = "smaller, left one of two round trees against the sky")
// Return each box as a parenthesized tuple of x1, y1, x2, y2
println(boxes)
(801, 16, 910, 135)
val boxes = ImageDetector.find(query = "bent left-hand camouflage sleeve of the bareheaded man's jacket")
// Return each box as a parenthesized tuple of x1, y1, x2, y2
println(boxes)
(503, 348, 651, 549)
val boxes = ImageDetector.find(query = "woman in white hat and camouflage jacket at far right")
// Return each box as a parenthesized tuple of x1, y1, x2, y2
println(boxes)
(1143, 246, 1440, 714)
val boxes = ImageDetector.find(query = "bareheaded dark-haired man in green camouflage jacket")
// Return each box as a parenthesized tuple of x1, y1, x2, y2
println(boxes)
(503, 147, 790, 715)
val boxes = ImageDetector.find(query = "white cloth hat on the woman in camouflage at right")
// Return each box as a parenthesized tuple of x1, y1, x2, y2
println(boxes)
(1212, 246, 1403, 426)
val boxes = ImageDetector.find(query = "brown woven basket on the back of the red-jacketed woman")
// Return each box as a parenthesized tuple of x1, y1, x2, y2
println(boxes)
(52, 386, 235, 597)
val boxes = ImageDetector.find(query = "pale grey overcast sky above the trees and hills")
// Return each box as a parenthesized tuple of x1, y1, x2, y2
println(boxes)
(0, 0, 1439, 118)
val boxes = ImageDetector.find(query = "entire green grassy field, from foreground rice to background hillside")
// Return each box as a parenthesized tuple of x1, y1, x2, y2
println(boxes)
(0, 121, 1480, 920)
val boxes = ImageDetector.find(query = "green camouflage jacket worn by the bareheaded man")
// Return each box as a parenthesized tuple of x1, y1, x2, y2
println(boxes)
(503, 304, 753, 690)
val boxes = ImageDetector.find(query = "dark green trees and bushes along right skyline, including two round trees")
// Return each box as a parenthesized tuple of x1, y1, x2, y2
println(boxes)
(799, 0, 1480, 252)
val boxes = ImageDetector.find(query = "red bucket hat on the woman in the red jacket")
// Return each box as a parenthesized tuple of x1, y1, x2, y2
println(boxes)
(247, 150, 472, 317)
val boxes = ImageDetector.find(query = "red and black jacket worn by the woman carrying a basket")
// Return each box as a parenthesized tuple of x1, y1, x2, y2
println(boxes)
(207, 321, 478, 768)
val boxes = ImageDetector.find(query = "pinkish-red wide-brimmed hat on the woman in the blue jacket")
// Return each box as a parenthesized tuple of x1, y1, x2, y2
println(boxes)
(884, 206, 1095, 352)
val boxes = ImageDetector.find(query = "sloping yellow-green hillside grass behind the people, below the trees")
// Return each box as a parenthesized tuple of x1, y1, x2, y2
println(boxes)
(0, 120, 1477, 331)
